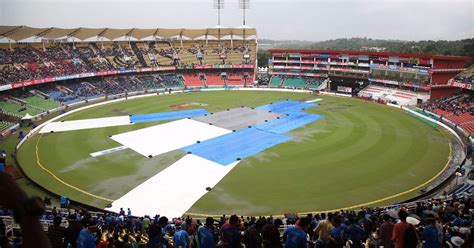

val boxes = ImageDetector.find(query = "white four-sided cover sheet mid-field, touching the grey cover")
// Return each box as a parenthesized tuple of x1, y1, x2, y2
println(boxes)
(111, 119, 232, 157)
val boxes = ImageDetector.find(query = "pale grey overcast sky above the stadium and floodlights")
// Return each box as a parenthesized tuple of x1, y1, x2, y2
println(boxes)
(0, 0, 474, 41)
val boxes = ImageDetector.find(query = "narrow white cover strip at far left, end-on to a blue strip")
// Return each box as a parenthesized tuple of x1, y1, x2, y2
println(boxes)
(40, 116, 131, 133)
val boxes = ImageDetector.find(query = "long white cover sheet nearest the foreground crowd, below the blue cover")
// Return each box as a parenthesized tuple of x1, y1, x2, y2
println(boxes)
(107, 154, 239, 218)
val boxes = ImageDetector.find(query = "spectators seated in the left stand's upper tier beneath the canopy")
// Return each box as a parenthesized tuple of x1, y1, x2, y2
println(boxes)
(0, 41, 256, 85)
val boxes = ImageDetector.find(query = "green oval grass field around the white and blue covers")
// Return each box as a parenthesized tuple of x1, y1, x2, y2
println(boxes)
(18, 91, 450, 215)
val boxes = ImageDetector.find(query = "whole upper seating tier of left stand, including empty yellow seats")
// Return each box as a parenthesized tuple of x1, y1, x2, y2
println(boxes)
(0, 40, 257, 85)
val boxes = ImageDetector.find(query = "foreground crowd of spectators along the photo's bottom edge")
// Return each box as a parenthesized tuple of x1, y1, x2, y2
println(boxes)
(0, 187, 474, 248)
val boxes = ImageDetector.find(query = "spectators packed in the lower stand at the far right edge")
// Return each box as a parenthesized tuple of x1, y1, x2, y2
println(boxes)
(422, 94, 474, 115)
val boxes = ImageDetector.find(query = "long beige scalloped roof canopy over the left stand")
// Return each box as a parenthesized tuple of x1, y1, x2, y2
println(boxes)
(0, 26, 257, 41)
